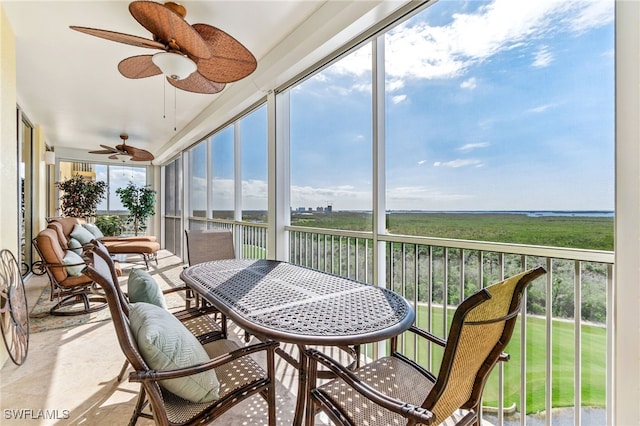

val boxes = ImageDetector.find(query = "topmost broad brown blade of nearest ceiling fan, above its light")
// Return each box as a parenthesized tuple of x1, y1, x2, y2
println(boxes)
(129, 1, 211, 58)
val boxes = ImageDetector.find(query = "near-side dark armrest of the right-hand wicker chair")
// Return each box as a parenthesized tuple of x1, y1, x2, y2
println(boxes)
(305, 349, 435, 425)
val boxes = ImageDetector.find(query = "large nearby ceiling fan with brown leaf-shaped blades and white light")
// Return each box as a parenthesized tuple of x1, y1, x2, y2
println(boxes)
(70, 1, 257, 94)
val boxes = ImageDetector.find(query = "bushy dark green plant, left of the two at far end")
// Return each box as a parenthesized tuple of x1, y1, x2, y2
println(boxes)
(56, 176, 107, 220)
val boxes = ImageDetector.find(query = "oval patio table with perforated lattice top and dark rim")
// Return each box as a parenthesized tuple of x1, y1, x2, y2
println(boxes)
(180, 259, 415, 425)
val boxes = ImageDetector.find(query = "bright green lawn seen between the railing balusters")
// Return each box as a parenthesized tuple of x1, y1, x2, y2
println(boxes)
(405, 306, 606, 413)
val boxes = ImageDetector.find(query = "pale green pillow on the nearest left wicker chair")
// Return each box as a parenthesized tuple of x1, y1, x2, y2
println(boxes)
(129, 302, 220, 402)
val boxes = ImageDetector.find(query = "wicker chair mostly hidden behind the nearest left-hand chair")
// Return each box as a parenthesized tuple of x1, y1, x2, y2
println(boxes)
(91, 240, 227, 382)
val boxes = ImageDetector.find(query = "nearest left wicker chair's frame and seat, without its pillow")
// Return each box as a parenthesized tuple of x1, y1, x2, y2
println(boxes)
(83, 243, 278, 426)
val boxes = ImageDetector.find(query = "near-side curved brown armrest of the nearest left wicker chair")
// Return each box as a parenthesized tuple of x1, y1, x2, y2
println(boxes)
(129, 341, 279, 382)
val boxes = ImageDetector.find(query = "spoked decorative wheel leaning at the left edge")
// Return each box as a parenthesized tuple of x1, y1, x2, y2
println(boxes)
(0, 250, 29, 365)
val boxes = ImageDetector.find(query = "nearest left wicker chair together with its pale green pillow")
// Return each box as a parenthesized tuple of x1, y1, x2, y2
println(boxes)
(83, 243, 278, 426)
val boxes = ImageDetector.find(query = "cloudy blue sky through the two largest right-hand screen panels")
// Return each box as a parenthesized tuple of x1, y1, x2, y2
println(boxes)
(291, 0, 614, 210)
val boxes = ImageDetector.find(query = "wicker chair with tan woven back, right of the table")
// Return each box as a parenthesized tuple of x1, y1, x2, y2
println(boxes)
(305, 267, 546, 425)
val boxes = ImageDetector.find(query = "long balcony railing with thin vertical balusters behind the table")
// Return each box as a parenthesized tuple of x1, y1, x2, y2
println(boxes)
(188, 222, 614, 425)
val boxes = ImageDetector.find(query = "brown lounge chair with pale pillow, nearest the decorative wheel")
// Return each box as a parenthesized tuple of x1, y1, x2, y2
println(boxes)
(32, 228, 107, 316)
